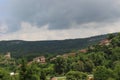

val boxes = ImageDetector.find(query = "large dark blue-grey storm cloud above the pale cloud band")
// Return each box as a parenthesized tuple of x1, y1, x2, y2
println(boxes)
(11, 0, 120, 29)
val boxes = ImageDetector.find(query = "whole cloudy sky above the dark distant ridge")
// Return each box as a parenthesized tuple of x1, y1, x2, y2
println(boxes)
(0, 0, 120, 41)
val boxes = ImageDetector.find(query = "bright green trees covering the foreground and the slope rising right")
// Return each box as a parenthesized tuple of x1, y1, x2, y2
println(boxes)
(0, 33, 120, 80)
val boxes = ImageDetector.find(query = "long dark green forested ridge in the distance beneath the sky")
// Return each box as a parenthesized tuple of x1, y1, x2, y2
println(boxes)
(0, 35, 107, 58)
